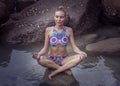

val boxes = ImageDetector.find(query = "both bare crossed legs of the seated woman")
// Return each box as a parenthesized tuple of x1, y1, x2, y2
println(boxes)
(35, 54, 84, 79)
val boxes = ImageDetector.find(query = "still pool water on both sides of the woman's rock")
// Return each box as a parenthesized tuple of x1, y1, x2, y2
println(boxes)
(0, 43, 120, 86)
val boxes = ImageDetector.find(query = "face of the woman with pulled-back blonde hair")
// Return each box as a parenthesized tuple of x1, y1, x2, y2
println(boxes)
(54, 11, 66, 26)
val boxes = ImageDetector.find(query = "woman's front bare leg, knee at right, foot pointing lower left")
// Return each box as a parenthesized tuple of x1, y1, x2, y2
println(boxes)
(48, 55, 82, 79)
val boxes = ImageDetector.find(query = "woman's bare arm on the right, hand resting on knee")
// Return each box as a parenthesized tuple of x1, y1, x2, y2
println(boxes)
(68, 28, 87, 57)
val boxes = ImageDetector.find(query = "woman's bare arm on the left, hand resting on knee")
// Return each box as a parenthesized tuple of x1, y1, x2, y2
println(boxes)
(37, 27, 50, 58)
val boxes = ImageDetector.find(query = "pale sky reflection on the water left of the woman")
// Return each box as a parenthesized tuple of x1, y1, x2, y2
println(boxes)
(0, 49, 44, 86)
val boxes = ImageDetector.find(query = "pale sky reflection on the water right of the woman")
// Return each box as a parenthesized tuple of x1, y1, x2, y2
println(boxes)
(73, 56, 120, 86)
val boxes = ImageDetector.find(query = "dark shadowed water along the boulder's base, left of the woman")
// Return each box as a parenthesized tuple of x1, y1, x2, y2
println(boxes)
(0, 43, 43, 67)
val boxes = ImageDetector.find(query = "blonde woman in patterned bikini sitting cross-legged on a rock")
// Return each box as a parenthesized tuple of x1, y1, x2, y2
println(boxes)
(34, 6, 87, 79)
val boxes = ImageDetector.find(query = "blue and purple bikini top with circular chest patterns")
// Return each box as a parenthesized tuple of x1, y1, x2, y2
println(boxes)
(49, 27, 69, 46)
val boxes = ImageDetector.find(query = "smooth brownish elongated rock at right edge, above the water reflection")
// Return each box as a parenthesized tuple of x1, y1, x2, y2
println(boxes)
(86, 38, 120, 54)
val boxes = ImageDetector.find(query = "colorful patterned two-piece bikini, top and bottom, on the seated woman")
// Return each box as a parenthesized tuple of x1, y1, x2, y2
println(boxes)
(48, 27, 69, 65)
